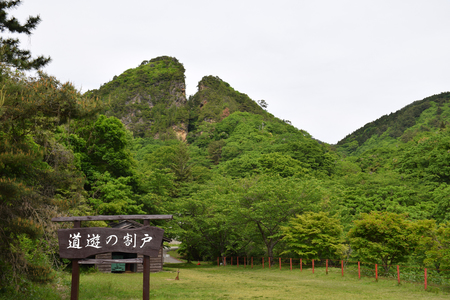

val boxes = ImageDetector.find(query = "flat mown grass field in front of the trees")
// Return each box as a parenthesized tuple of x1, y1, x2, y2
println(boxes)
(51, 264, 449, 300)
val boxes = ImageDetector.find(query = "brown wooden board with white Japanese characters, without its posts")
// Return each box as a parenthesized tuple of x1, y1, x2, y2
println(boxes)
(58, 226, 164, 259)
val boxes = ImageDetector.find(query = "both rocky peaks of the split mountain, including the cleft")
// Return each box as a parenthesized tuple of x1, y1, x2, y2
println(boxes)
(88, 56, 268, 141)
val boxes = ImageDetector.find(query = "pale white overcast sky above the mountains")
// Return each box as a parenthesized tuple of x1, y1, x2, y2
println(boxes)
(10, 0, 450, 144)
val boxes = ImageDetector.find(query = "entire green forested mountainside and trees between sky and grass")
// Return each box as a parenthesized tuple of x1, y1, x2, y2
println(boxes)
(0, 56, 450, 293)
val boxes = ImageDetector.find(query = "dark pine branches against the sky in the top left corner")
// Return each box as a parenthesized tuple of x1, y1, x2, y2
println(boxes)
(0, 0, 50, 70)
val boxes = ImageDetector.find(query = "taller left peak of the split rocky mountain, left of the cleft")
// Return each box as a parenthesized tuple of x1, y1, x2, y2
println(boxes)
(89, 56, 189, 140)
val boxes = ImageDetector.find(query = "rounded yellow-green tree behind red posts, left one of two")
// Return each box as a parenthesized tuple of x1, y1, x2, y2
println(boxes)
(281, 212, 344, 259)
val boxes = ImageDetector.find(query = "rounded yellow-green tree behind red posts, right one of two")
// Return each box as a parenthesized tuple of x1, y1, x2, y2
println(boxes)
(348, 212, 416, 273)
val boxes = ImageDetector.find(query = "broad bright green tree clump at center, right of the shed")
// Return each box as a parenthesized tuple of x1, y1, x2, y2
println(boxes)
(173, 175, 321, 258)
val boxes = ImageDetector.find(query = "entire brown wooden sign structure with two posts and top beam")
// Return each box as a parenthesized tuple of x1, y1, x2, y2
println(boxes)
(52, 215, 173, 300)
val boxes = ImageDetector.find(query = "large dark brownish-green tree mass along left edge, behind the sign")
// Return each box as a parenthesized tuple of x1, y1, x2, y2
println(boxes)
(0, 66, 96, 289)
